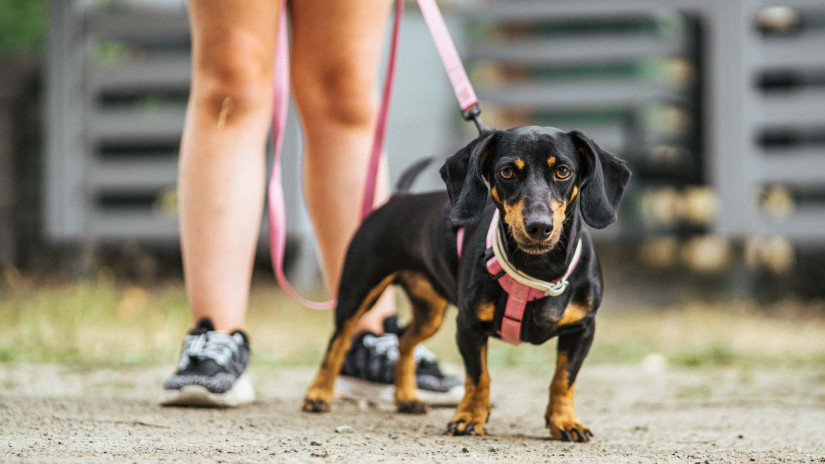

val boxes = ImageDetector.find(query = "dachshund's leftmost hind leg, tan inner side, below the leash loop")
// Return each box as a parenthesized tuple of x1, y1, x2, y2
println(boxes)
(303, 273, 395, 412)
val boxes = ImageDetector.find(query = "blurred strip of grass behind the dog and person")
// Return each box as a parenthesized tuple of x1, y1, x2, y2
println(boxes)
(0, 270, 825, 369)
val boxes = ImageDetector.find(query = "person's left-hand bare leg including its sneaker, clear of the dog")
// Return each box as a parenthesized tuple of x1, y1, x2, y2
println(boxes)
(161, 0, 280, 406)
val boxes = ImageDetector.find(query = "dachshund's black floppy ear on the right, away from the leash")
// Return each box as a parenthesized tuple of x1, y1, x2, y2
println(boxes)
(568, 131, 630, 229)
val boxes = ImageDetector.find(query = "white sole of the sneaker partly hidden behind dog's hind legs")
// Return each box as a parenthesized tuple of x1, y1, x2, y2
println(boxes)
(335, 375, 464, 408)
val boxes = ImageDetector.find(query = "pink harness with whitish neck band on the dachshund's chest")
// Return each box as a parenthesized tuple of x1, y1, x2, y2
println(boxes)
(456, 210, 582, 345)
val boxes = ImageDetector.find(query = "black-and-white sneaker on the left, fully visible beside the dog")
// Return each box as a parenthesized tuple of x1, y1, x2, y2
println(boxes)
(160, 318, 255, 407)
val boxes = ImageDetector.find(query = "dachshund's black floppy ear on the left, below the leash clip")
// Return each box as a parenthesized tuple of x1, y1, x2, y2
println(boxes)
(440, 131, 498, 226)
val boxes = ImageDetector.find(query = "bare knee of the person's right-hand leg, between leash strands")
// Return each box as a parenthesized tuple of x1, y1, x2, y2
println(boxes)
(293, 59, 377, 129)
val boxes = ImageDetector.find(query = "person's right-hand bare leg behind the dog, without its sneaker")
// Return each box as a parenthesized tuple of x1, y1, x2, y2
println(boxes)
(290, 0, 394, 334)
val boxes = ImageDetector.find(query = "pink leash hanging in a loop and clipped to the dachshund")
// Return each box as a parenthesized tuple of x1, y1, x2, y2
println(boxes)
(269, 0, 484, 309)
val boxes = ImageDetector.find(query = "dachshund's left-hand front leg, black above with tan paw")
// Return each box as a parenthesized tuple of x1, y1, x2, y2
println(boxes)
(445, 316, 490, 436)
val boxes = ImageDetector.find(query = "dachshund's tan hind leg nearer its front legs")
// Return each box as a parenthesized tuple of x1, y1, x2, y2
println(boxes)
(395, 272, 448, 414)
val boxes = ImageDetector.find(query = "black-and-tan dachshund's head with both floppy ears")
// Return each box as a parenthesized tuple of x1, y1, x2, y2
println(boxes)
(441, 126, 630, 254)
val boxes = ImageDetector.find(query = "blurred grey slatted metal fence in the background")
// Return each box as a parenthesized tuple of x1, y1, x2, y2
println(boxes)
(46, 0, 825, 272)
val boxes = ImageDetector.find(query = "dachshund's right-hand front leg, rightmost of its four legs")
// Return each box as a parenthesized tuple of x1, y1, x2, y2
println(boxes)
(544, 319, 595, 442)
